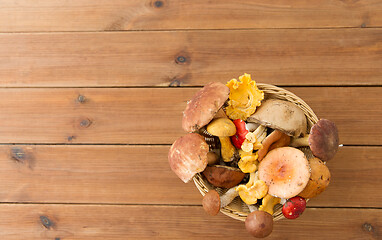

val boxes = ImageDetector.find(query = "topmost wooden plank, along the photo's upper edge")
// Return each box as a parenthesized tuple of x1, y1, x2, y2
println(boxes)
(0, 0, 382, 32)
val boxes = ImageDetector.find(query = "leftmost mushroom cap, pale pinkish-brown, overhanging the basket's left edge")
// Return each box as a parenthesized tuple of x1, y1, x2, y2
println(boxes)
(168, 133, 209, 183)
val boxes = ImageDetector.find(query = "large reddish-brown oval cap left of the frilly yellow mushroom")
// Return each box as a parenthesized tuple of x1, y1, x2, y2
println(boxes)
(182, 82, 229, 132)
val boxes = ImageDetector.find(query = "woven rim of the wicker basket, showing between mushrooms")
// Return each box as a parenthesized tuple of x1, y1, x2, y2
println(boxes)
(193, 83, 318, 221)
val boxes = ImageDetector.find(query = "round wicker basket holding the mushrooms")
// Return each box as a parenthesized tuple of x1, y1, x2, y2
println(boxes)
(193, 83, 318, 221)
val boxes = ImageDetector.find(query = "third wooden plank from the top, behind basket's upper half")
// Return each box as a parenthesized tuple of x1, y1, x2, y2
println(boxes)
(0, 87, 382, 145)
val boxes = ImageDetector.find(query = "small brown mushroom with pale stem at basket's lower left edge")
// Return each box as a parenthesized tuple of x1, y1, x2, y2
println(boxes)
(202, 188, 238, 216)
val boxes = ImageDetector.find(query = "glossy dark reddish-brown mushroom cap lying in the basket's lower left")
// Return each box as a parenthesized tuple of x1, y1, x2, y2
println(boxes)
(203, 165, 245, 188)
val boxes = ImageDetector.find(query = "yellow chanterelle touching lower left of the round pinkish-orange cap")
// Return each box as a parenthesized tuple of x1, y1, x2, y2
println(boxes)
(236, 172, 268, 204)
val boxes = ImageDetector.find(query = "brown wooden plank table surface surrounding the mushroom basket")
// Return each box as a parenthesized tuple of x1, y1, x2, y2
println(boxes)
(0, 0, 382, 240)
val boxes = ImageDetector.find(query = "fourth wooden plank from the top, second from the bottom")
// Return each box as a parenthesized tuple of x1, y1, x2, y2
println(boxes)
(0, 145, 382, 208)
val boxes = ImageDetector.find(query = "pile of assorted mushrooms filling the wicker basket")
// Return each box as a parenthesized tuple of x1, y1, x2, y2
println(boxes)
(168, 74, 339, 238)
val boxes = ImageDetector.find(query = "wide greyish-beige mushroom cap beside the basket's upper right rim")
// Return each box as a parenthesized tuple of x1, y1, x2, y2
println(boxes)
(247, 99, 307, 137)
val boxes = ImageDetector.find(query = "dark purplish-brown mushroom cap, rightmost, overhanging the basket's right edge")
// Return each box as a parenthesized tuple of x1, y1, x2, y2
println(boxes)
(309, 119, 339, 162)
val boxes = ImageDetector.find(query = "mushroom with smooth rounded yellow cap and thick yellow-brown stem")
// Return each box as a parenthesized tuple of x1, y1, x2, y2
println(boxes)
(207, 118, 236, 162)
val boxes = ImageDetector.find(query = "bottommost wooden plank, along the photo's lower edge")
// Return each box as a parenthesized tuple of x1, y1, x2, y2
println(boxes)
(0, 204, 382, 240)
